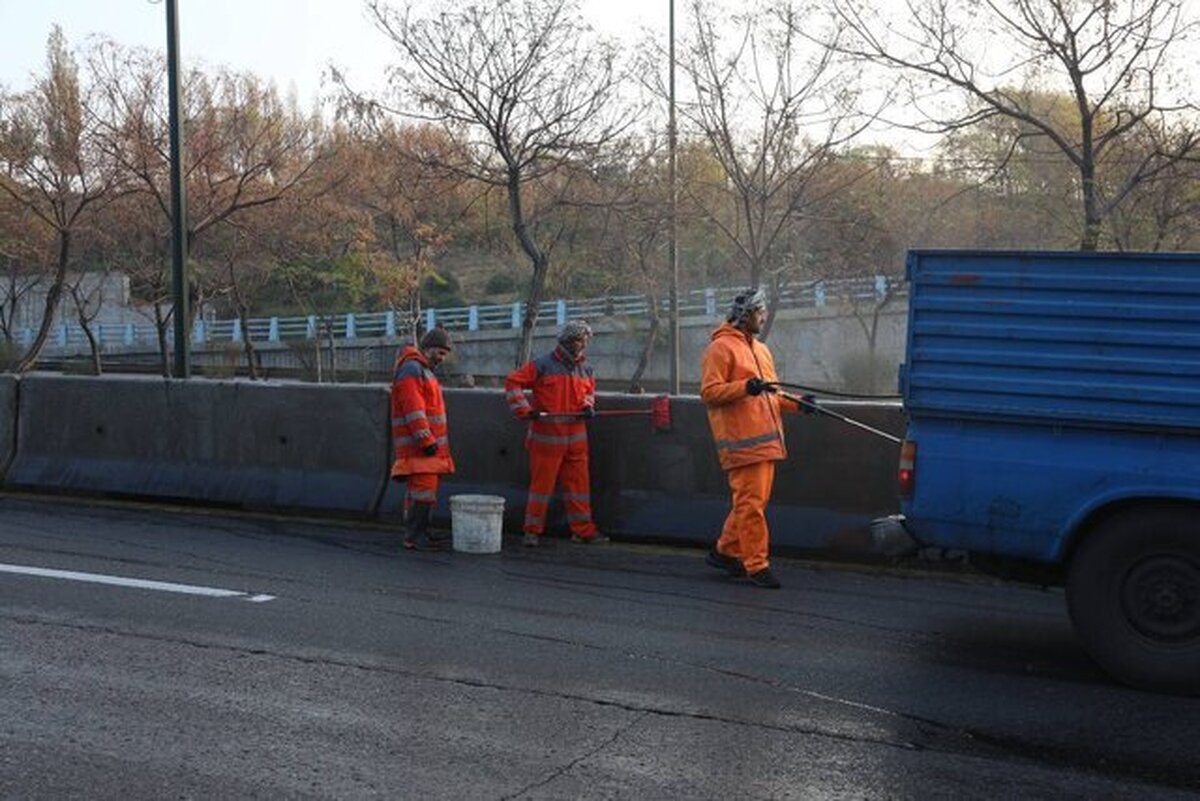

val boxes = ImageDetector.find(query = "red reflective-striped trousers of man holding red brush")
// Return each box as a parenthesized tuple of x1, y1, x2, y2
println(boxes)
(524, 440, 596, 537)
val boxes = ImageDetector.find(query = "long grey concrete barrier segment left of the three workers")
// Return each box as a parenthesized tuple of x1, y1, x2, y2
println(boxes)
(5, 375, 388, 514)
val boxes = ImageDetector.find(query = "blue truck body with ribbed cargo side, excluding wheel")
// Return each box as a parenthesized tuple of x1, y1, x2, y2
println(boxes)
(901, 251, 1200, 561)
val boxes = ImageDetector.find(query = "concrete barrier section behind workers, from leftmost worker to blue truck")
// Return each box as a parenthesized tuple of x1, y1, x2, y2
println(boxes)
(382, 390, 904, 550)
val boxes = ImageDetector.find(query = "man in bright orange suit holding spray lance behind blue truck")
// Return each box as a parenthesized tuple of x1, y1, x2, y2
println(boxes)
(700, 289, 798, 589)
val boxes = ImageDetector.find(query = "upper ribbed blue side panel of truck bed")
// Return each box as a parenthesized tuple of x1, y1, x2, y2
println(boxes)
(901, 251, 1200, 430)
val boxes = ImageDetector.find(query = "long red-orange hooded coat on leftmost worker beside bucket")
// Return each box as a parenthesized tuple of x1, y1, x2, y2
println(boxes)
(391, 345, 454, 476)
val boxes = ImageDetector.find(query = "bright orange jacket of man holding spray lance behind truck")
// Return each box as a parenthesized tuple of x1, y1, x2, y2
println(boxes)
(700, 323, 797, 470)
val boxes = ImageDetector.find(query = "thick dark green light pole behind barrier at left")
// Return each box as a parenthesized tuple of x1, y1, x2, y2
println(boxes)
(166, 0, 192, 378)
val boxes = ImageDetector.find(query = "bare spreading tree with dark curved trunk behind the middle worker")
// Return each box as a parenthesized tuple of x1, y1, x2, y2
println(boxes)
(343, 0, 625, 363)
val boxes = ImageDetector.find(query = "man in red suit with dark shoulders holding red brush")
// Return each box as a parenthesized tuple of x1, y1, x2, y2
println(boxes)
(504, 320, 608, 548)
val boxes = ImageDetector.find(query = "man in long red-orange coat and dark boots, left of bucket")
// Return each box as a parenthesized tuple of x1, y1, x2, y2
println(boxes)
(391, 329, 454, 550)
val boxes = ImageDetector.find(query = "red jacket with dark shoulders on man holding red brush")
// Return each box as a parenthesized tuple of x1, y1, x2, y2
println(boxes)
(504, 345, 596, 447)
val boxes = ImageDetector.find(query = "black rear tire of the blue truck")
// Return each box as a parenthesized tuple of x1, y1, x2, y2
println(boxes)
(1067, 507, 1200, 694)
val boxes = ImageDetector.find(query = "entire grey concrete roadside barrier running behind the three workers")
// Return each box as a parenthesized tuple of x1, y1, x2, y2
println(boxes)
(0, 375, 904, 550)
